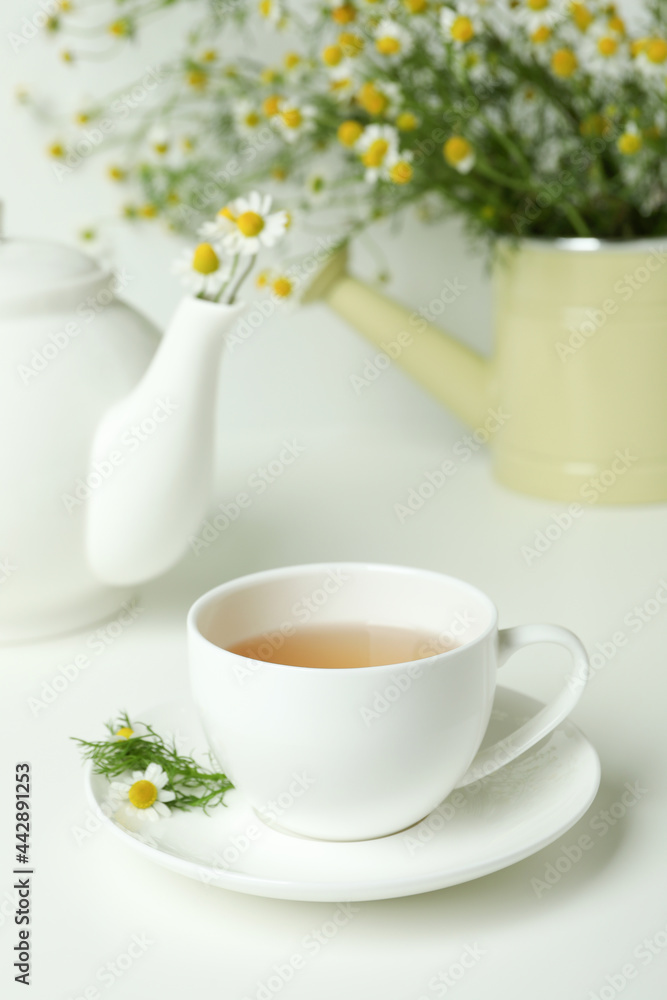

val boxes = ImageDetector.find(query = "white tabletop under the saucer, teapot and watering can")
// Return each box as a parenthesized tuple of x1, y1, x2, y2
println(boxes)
(0, 415, 667, 1000)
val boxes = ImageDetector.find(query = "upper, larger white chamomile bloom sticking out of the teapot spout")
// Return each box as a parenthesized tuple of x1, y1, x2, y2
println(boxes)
(199, 191, 289, 257)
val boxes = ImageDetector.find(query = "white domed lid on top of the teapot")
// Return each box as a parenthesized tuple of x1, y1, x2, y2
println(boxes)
(0, 239, 106, 304)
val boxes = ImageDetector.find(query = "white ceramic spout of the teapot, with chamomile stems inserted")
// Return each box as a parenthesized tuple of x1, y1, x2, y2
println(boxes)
(86, 298, 243, 585)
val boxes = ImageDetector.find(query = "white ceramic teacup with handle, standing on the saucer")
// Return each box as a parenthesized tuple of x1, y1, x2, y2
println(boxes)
(188, 563, 589, 840)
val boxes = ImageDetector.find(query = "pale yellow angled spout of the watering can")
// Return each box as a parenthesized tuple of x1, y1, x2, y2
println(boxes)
(301, 248, 491, 427)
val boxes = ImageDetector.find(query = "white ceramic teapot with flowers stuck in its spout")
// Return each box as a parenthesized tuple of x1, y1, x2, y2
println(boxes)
(0, 239, 241, 641)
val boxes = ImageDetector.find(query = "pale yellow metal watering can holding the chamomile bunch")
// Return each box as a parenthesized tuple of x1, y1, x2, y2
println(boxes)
(302, 237, 667, 507)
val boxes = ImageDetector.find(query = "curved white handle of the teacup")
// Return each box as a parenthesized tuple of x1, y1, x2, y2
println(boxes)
(456, 625, 590, 788)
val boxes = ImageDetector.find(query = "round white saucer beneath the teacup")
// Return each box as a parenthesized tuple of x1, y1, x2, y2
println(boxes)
(86, 687, 600, 902)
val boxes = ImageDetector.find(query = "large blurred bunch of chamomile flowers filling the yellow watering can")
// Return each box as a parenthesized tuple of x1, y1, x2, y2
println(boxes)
(35, 0, 667, 241)
